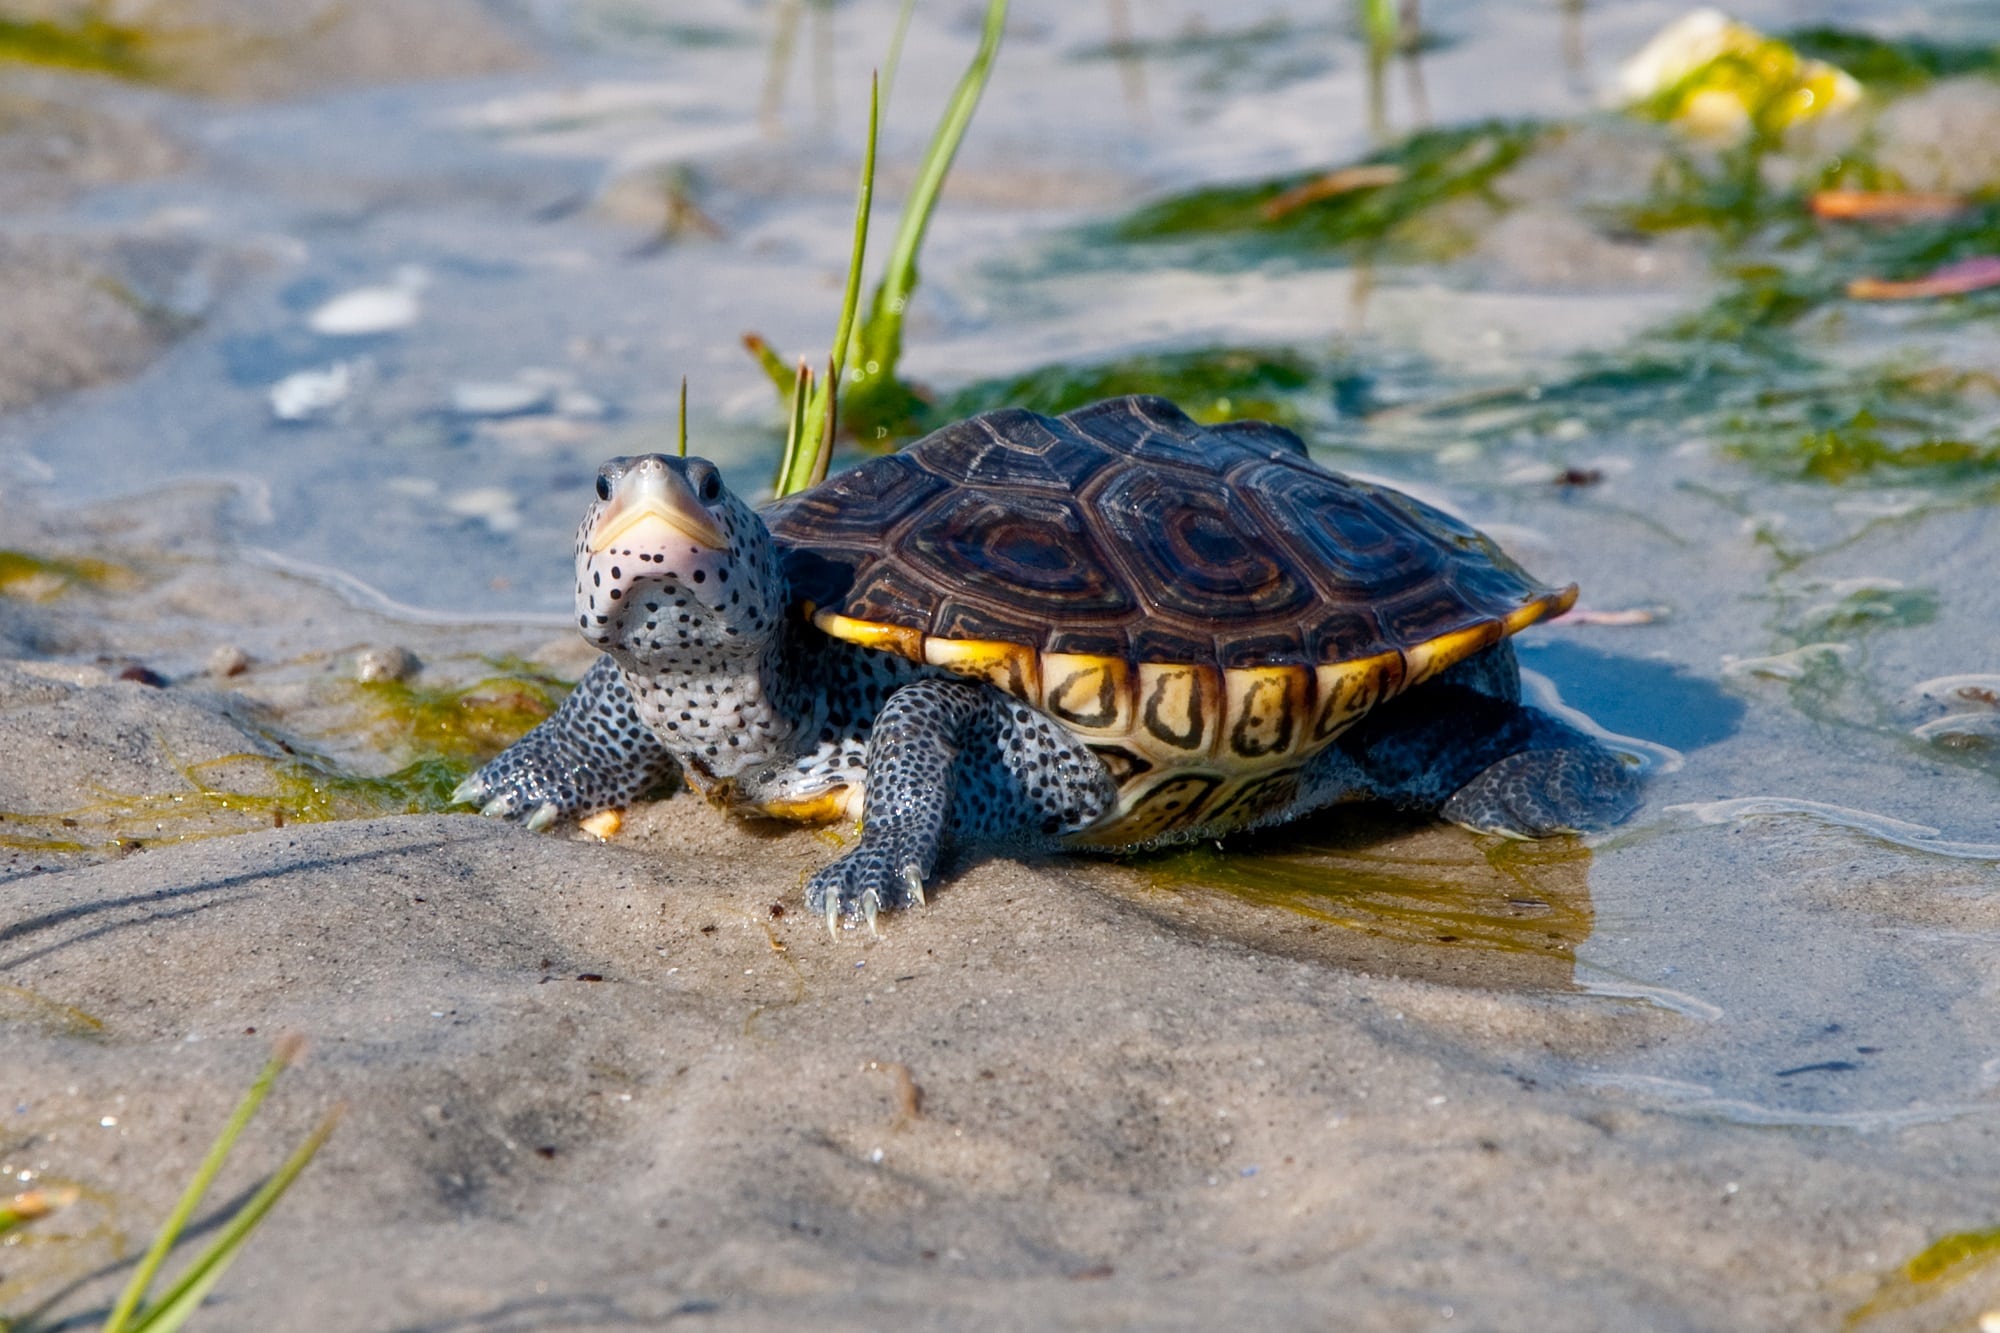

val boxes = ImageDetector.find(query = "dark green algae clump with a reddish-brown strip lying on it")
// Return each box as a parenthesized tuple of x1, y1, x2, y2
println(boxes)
(1106, 120, 1546, 262)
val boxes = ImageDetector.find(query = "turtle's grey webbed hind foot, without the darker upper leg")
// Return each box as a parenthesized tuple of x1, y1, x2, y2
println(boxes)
(1440, 745, 1640, 839)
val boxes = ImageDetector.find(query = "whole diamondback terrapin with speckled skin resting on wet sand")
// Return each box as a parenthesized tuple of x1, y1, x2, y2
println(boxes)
(454, 396, 1640, 929)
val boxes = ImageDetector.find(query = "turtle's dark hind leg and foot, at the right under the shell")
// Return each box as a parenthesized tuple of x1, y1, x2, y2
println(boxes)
(1314, 679, 1640, 839)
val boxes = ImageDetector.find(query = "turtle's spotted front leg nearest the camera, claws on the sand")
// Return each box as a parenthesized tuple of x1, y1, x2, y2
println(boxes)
(806, 681, 1118, 929)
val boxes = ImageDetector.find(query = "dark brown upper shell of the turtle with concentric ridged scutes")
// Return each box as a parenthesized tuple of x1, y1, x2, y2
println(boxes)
(766, 398, 1574, 671)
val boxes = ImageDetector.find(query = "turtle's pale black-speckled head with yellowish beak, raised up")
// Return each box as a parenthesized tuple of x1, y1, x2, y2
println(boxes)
(576, 454, 784, 671)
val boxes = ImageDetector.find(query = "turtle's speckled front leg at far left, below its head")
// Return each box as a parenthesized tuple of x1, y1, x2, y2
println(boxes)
(452, 656, 674, 829)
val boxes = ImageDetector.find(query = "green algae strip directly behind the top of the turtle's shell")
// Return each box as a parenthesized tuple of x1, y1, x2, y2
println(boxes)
(934, 346, 1336, 426)
